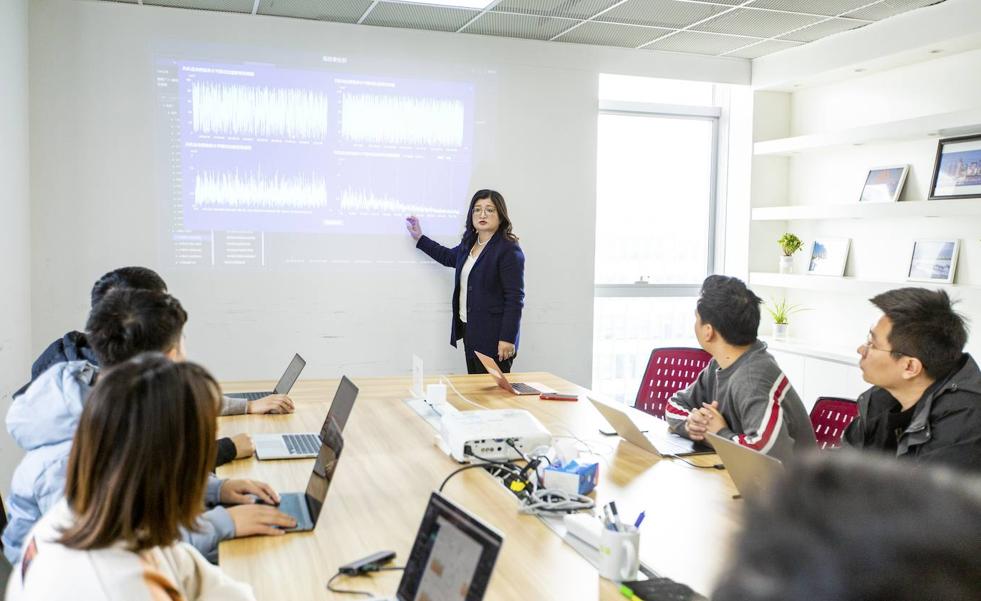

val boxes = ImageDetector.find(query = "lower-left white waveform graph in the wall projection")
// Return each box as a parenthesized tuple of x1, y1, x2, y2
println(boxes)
(192, 170, 327, 211)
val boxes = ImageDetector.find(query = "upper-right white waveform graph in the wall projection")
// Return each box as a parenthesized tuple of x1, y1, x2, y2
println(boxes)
(341, 92, 465, 148)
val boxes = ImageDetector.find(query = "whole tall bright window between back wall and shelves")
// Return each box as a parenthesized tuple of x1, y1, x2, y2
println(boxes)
(592, 76, 721, 403)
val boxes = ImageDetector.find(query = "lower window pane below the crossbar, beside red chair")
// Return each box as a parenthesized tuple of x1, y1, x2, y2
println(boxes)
(592, 297, 698, 405)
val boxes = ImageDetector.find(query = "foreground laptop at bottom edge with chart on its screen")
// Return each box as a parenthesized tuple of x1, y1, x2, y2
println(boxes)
(374, 492, 504, 601)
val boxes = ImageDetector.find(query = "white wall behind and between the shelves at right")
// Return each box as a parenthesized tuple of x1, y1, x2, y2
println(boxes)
(751, 45, 981, 380)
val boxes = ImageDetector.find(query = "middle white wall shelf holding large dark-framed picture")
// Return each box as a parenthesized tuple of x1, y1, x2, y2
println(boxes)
(753, 198, 981, 221)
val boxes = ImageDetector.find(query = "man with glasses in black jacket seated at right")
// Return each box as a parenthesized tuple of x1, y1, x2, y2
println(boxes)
(844, 288, 981, 471)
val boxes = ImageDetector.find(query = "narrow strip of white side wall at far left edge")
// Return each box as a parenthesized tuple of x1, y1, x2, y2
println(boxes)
(0, 0, 32, 496)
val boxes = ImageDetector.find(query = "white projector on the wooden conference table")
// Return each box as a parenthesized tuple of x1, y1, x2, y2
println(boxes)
(440, 409, 552, 462)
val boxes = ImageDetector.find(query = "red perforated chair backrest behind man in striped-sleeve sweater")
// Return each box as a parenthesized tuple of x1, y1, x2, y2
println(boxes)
(634, 347, 712, 418)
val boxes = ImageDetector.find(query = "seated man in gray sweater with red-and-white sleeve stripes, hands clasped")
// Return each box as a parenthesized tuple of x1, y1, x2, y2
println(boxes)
(664, 275, 817, 460)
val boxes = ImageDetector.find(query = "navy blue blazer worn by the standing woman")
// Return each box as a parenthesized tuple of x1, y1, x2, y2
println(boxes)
(416, 232, 525, 357)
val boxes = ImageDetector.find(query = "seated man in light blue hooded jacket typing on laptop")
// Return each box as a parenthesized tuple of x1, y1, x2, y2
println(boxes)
(3, 290, 294, 563)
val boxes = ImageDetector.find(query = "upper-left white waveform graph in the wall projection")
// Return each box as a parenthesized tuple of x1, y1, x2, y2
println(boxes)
(190, 81, 330, 141)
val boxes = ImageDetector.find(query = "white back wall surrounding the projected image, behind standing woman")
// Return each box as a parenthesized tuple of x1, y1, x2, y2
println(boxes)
(31, 0, 749, 390)
